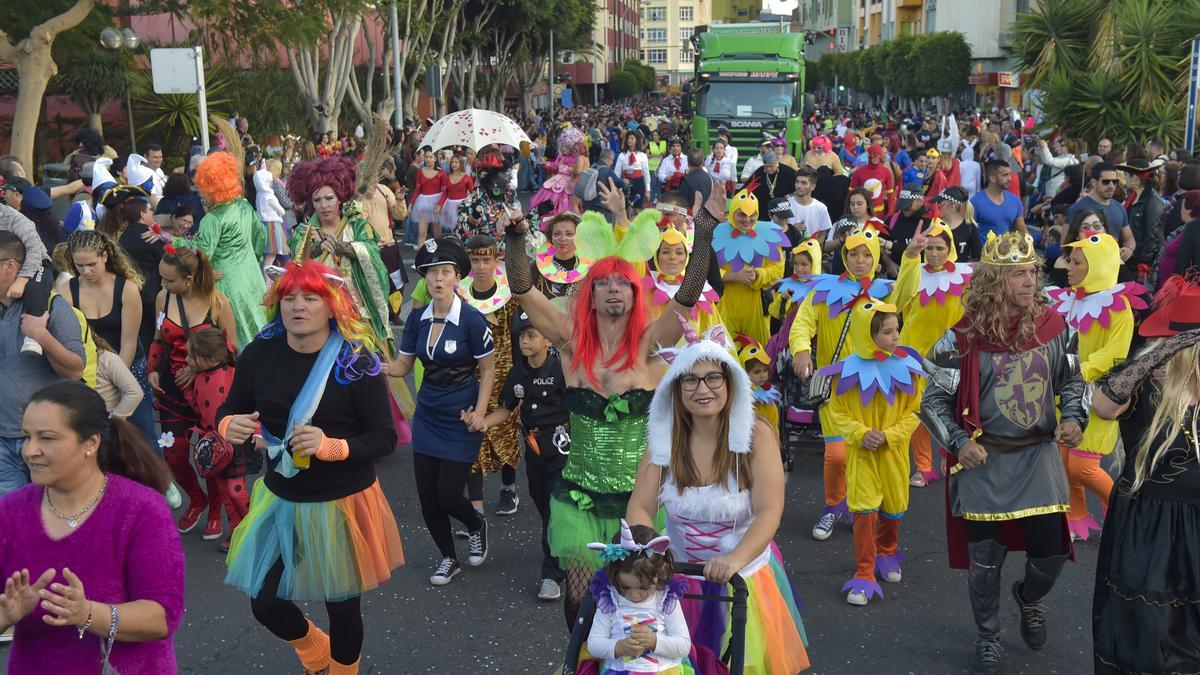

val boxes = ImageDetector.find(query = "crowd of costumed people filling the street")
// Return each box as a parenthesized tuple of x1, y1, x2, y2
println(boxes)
(0, 97, 1200, 674)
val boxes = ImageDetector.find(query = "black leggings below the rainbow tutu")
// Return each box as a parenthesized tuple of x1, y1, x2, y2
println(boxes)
(250, 558, 362, 665)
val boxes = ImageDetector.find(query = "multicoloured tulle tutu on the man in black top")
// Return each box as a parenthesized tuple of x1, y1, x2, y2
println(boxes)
(226, 478, 404, 602)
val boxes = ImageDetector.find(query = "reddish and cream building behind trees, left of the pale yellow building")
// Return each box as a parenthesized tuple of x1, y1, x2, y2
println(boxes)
(554, 0, 641, 103)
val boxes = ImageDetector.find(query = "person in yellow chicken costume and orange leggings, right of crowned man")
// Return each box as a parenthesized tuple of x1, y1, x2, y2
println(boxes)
(1049, 233, 1147, 539)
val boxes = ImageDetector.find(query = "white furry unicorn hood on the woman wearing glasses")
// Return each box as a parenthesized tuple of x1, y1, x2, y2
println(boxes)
(646, 315, 754, 466)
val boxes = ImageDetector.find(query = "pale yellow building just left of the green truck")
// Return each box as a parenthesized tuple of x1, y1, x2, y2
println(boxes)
(638, 0, 713, 88)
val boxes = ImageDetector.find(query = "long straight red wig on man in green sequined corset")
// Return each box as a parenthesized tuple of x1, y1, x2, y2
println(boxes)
(571, 257, 650, 390)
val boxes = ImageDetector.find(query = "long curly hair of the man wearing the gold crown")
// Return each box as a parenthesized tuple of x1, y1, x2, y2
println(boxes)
(962, 261, 1050, 348)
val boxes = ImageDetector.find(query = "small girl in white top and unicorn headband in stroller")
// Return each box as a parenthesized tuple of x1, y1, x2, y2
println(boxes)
(588, 519, 696, 675)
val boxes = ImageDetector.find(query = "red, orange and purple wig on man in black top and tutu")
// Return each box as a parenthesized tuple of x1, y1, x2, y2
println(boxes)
(259, 261, 382, 382)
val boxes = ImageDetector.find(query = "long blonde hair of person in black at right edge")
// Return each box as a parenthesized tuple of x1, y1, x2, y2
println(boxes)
(1129, 345, 1200, 494)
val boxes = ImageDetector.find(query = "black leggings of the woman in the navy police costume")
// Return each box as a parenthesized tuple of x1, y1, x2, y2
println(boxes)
(413, 453, 484, 560)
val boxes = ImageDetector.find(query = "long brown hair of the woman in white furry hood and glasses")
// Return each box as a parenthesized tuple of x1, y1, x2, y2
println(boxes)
(671, 362, 752, 495)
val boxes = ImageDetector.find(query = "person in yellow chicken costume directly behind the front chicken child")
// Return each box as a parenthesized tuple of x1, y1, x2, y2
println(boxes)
(780, 223, 925, 540)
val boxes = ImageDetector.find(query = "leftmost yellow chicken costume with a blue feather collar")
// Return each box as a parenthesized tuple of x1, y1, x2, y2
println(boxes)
(713, 181, 787, 344)
